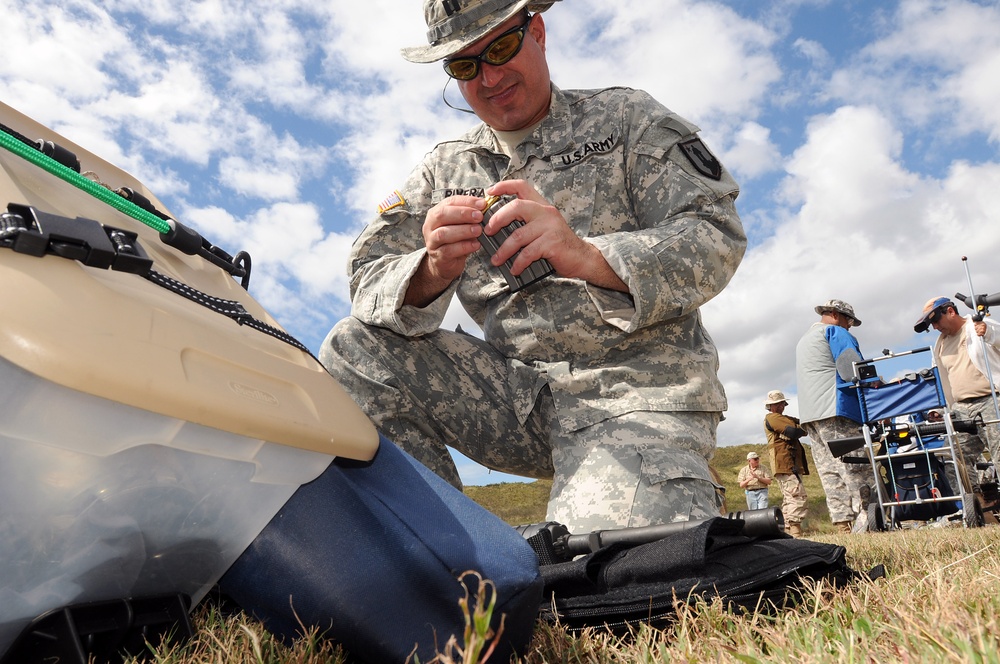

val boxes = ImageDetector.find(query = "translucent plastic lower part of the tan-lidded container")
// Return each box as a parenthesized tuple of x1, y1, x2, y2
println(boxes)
(0, 359, 333, 652)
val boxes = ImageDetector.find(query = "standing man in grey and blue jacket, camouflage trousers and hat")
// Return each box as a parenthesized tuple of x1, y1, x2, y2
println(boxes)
(795, 300, 874, 533)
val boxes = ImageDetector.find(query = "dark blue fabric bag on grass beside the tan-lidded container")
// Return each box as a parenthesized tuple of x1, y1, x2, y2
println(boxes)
(219, 438, 542, 663)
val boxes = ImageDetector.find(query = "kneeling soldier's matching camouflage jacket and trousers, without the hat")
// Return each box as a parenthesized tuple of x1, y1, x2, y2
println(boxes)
(320, 88, 746, 527)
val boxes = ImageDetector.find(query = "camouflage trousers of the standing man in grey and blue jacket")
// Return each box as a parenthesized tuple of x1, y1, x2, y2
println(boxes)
(802, 417, 875, 523)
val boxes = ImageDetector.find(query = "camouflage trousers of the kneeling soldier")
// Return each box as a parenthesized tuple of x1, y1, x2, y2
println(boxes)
(319, 317, 722, 533)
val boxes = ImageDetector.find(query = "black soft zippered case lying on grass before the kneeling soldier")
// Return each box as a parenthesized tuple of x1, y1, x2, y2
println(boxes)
(541, 517, 868, 634)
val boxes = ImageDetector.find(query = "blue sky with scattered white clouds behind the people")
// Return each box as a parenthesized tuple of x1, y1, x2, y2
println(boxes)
(0, 0, 1000, 484)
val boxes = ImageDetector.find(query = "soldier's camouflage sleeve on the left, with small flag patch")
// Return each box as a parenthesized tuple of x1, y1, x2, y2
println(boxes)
(348, 164, 457, 336)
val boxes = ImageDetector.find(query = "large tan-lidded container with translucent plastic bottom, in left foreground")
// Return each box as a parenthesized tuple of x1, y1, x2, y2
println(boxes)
(0, 98, 378, 655)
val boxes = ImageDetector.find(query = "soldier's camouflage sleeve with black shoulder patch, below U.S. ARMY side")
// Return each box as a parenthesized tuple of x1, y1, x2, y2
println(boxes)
(589, 97, 747, 331)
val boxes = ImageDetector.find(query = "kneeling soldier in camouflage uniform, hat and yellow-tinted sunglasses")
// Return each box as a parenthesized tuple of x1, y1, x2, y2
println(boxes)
(320, 0, 746, 532)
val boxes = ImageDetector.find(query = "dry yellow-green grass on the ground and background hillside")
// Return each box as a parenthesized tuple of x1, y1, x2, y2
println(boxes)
(113, 446, 1000, 664)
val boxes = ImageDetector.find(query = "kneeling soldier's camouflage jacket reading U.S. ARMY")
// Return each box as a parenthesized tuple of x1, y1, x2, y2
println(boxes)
(349, 88, 746, 431)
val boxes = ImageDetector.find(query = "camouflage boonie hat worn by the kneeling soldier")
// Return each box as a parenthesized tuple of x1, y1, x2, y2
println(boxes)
(401, 0, 559, 63)
